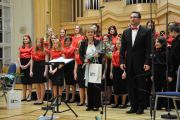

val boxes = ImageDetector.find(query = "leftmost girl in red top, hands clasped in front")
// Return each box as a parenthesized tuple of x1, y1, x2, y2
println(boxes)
(18, 35, 32, 101)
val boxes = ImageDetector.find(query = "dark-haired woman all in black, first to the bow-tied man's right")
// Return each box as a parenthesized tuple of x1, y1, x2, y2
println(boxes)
(154, 37, 167, 109)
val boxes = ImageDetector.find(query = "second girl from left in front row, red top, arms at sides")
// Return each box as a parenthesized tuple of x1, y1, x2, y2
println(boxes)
(30, 38, 48, 105)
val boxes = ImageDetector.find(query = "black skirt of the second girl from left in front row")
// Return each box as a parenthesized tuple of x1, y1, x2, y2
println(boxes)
(33, 60, 46, 83)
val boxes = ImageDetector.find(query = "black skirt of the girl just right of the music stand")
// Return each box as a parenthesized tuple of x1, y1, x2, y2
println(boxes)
(63, 61, 76, 85)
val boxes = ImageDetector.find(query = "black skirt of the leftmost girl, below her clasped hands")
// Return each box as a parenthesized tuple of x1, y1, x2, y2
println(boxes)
(20, 58, 32, 85)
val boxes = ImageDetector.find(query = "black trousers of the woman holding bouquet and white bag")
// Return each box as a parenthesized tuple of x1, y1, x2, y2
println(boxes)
(87, 83, 101, 109)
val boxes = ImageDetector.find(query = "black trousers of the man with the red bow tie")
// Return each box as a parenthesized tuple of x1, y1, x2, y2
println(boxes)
(127, 69, 146, 109)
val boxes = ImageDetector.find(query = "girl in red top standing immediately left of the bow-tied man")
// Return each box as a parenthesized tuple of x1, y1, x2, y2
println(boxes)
(110, 40, 127, 108)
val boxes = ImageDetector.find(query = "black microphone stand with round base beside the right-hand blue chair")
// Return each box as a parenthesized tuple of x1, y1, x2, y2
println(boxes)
(161, 0, 177, 119)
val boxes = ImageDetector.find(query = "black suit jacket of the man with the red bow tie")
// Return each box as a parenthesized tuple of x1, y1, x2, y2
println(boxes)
(120, 26, 151, 73)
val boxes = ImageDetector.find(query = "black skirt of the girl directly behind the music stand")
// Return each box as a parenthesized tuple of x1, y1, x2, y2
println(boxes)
(49, 66, 64, 86)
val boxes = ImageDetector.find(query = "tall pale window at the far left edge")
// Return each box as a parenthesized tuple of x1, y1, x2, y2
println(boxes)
(0, 0, 11, 66)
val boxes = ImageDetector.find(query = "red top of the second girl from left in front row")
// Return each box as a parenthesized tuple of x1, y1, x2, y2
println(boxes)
(32, 50, 46, 61)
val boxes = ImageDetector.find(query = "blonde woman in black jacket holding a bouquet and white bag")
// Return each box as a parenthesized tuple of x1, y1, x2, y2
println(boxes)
(79, 27, 102, 111)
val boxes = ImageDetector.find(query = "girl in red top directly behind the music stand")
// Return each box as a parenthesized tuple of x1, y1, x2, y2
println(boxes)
(49, 39, 64, 100)
